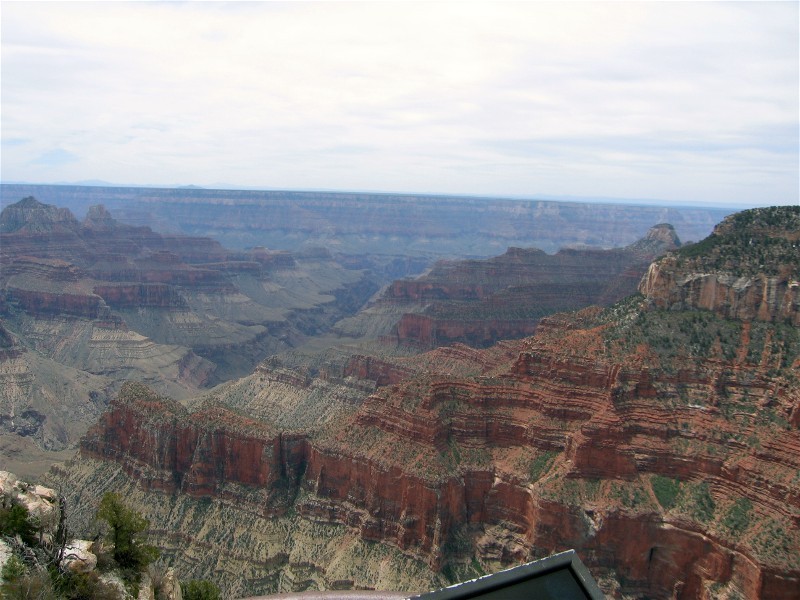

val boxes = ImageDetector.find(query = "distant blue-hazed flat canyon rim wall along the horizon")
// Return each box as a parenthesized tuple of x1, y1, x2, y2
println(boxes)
(0, 184, 730, 254)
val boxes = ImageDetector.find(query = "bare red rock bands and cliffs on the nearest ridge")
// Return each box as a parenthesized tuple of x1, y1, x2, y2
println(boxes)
(82, 318, 800, 598)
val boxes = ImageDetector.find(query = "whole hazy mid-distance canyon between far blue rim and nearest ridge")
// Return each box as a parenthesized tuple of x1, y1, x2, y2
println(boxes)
(0, 192, 680, 476)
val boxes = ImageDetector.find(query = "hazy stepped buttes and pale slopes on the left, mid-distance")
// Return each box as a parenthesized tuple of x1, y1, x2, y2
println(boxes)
(0, 197, 382, 475)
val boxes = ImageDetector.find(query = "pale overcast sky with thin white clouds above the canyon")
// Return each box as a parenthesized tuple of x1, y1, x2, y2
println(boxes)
(0, 1, 800, 207)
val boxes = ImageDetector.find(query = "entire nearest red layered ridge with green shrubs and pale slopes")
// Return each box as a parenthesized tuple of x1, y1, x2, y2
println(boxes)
(43, 207, 800, 599)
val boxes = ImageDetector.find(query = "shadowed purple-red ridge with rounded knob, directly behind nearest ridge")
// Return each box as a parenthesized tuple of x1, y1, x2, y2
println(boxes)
(344, 224, 680, 349)
